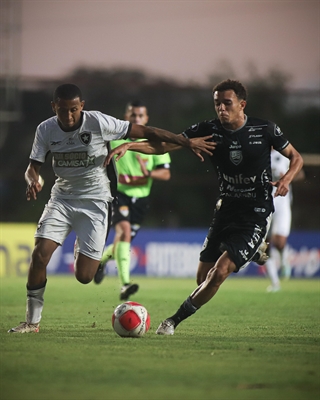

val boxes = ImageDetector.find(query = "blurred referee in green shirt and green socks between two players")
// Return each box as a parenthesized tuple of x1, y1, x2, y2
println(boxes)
(94, 100, 171, 300)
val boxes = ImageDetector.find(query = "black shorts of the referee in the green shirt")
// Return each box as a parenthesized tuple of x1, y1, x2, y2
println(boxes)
(112, 192, 150, 239)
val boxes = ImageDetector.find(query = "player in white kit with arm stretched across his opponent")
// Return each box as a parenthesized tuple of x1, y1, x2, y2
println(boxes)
(9, 84, 214, 333)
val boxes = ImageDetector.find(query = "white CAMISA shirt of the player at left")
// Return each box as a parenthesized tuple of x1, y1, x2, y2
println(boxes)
(30, 111, 129, 201)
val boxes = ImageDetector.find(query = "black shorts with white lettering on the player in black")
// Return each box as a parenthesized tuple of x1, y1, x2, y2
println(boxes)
(200, 200, 272, 272)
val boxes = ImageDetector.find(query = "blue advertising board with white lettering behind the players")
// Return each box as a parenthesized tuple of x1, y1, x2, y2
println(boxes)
(48, 229, 320, 278)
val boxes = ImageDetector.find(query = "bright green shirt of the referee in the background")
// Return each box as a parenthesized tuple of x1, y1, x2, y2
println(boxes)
(110, 139, 171, 198)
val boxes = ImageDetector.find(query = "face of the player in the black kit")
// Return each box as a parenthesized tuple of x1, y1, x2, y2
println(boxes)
(213, 90, 246, 129)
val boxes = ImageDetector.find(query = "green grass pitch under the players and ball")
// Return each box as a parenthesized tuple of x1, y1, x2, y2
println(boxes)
(0, 276, 320, 400)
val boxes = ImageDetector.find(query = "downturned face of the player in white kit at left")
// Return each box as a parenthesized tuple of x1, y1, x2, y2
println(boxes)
(51, 97, 84, 132)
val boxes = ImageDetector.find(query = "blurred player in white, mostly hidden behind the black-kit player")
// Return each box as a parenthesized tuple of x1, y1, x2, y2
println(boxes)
(266, 150, 303, 292)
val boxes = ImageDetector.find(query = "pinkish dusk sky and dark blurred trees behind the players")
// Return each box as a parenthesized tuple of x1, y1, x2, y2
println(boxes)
(0, 0, 320, 230)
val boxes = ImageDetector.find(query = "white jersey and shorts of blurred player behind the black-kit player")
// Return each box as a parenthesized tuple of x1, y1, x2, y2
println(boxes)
(271, 150, 291, 237)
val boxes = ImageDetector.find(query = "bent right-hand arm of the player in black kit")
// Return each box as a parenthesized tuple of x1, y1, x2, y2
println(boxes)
(271, 144, 303, 197)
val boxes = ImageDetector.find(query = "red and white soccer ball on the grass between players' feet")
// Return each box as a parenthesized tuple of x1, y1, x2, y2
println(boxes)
(112, 301, 150, 337)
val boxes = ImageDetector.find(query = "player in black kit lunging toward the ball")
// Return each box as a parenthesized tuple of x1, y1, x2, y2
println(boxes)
(105, 79, 303, 335)
